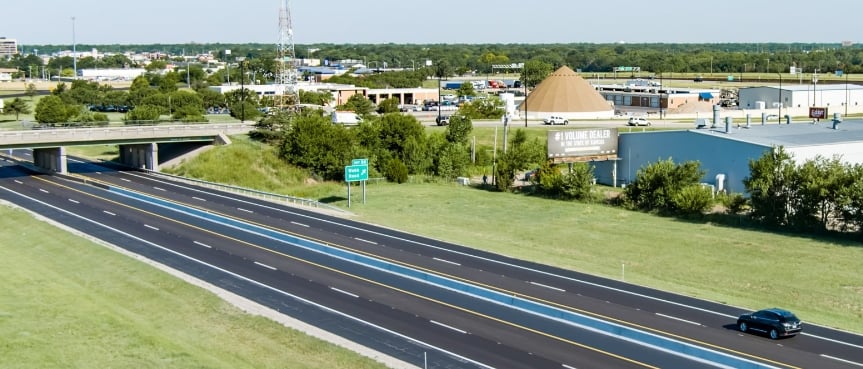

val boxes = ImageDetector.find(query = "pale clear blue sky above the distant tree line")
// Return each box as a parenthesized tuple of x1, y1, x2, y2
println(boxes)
(0, 0, 863, 45)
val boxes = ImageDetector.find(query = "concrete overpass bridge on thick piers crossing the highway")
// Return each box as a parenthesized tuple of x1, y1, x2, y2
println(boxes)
(0, 123, 254, 173)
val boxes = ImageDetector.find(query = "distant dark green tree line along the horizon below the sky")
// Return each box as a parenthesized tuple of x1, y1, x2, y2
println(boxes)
(0, 43, 863, 83)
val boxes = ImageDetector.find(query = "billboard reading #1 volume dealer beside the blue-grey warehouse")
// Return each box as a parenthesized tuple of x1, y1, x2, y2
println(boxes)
(548, 128, 617, 159)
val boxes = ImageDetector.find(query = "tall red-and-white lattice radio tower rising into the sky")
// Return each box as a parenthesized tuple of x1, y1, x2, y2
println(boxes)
(275, 0, 300, 110)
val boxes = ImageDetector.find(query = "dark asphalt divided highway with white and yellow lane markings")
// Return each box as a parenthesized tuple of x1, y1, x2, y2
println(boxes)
(0, 150, 863, 368)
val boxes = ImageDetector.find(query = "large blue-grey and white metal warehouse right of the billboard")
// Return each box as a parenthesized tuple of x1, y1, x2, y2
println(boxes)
(592, 120, 863, 193)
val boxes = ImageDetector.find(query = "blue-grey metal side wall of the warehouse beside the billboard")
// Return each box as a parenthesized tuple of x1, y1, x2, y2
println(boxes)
(592, 131, 770, 193)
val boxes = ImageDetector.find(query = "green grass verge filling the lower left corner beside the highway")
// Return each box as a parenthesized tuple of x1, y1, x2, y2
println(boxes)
(0, 205, 384, 369)
